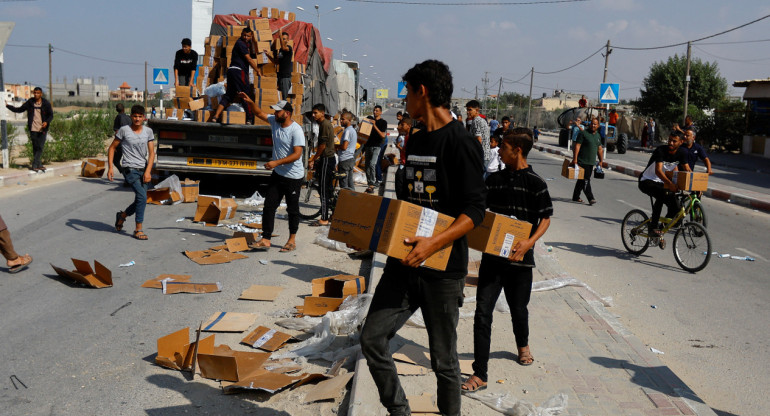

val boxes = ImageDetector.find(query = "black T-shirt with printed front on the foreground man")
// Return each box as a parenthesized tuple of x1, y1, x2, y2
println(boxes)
(387, 121, 486, 279)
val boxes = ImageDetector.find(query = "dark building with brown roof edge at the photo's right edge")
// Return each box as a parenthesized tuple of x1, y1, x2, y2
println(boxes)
(733, 78, 770, 158)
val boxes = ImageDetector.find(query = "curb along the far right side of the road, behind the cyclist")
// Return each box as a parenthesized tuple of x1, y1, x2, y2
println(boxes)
(532, 143, 770, 213)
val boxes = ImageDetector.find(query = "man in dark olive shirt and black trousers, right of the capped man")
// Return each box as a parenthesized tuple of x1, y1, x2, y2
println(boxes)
(308, 104, 337, 227)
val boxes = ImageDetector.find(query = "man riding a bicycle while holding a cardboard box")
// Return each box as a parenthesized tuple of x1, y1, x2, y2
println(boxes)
(639, 130, 691, 236)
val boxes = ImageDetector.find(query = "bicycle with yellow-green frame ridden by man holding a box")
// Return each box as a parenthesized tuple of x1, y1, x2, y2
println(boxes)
(620, 191, 711, 273)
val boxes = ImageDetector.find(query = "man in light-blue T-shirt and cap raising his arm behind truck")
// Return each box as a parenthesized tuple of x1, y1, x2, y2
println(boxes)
(238, 96, 305, 253)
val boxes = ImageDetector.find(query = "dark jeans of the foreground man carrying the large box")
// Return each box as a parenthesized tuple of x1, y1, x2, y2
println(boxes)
(361, 259, 465, 415)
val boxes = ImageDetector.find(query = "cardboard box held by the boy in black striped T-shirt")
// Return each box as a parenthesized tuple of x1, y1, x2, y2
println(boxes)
(467, 211, 532, 258)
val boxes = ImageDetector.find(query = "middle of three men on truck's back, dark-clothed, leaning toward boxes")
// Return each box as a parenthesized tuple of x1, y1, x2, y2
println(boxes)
(208, 26, 261, 121)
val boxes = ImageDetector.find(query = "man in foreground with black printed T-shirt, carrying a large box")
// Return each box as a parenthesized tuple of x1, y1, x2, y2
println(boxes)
(361, 60, 486, 415)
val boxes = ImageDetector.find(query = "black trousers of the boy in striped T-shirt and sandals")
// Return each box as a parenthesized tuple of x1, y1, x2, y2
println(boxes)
(473, 259, 532, 382)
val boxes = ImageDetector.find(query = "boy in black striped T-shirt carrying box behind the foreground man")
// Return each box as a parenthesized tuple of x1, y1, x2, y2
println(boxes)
(462, 128, 553, 392)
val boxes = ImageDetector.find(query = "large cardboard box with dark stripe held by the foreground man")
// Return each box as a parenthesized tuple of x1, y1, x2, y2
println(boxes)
(329, 190, 454, 270)
